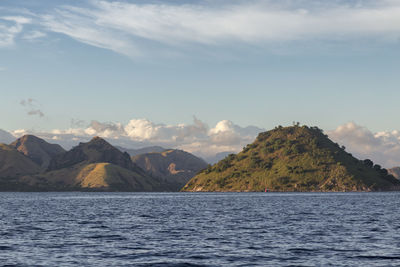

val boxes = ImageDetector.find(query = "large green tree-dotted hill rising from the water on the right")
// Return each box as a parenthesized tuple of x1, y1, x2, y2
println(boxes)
(182, 125, 400, 191)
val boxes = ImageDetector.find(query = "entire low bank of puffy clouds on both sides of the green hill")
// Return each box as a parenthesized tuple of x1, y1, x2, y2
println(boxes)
(0, 118, 400, 168)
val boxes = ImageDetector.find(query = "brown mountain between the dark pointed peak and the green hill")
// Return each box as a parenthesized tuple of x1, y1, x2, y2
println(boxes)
(132, 149, 207, 191)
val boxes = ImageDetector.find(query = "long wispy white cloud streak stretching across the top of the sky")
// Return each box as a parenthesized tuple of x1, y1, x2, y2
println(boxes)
(34, 0, 400, 56)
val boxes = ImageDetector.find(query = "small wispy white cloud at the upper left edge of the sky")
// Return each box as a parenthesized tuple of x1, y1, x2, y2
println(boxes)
(0, 16, 32, 47)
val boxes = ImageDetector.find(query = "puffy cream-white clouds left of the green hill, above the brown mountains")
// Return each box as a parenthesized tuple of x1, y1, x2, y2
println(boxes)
(13, 118, 263, 162)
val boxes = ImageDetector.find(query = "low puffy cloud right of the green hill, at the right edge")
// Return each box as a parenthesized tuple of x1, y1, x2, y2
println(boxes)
(328, 122, 400, 168)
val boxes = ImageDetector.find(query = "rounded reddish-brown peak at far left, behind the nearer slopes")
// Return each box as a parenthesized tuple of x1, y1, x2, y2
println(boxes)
(10, 135, 65, 169)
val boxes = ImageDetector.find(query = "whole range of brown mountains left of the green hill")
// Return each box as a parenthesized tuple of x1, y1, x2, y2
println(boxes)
(0, 135, 206, 191)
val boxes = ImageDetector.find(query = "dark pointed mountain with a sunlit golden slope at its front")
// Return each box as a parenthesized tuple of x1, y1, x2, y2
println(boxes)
(22, 137, 164, 191)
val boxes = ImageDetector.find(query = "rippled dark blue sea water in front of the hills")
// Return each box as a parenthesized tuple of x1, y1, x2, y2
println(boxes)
(0, 193, 400, 266)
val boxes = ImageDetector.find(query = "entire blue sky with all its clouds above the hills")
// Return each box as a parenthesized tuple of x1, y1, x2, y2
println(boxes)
(0, 0, 400, 167)
